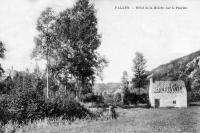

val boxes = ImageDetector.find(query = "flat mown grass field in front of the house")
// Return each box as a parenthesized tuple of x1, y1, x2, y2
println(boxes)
(23, 106, 200, 133)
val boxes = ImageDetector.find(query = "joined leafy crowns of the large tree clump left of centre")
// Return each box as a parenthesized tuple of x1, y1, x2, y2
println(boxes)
(33, 0, 107, 99)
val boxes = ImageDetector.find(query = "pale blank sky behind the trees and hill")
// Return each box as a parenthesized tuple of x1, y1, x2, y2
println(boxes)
(0, 0, 200, 82)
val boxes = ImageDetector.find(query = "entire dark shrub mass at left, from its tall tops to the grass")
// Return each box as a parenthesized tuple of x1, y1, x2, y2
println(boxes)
(0, 68, 92, 124)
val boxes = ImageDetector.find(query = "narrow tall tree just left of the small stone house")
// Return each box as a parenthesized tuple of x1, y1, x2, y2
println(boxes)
(132, 52, 147, 94)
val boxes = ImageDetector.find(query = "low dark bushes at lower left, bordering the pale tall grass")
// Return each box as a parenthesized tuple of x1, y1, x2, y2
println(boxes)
(0, 90, 93, 124)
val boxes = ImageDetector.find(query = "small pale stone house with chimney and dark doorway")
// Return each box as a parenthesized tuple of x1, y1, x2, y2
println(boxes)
(149, 76, 187, 108)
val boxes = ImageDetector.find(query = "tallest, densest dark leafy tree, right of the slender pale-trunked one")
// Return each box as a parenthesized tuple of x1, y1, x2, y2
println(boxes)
(56, 0, 106, 97)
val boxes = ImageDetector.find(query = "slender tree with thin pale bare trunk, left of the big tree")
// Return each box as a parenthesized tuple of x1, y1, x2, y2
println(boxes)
(32, 8, 57, 98)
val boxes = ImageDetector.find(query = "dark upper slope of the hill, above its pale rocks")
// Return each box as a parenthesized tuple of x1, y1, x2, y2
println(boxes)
(151, 50, 200, 80)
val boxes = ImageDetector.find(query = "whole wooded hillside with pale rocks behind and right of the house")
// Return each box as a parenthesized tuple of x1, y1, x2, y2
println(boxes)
(152, 51, 200, 101)
